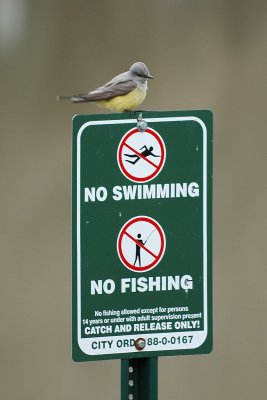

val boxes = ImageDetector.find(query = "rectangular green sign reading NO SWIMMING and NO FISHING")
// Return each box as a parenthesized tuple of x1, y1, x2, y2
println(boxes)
(73, 110, 212, 361)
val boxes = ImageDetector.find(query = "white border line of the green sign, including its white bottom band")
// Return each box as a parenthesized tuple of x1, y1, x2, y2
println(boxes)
(74, 116, 208, 356)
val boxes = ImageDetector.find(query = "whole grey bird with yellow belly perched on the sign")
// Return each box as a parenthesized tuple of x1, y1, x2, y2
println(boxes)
(58, 62, 153, 112)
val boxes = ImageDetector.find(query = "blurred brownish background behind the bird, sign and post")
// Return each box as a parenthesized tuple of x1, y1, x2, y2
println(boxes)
(0, 0, 267, 400)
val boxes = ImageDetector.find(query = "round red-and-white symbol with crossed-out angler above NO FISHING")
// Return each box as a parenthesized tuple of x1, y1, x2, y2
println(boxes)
(117, 216, 166, 272)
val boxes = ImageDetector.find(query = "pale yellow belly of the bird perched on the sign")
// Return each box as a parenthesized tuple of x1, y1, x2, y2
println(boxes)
(97, 88, 146, 112)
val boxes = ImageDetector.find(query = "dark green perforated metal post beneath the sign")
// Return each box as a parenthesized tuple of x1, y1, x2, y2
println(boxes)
(121, 357, 158, 400)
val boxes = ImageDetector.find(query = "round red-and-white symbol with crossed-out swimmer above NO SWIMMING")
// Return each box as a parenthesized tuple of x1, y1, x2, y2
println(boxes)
(117, 128, 166, 182)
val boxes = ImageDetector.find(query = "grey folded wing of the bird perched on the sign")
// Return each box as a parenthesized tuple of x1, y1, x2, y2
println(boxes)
(74, 73, 137, 101)
